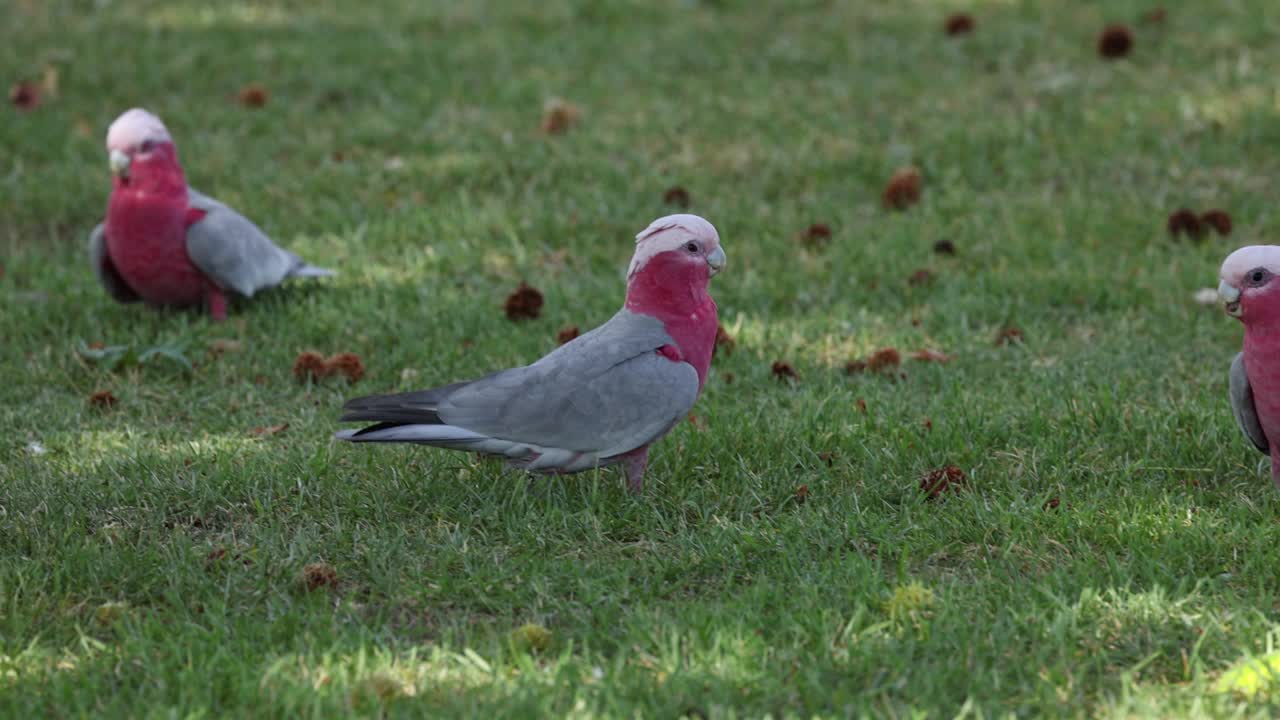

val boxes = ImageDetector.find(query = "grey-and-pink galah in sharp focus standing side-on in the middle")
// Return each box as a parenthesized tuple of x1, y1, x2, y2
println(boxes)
(337, 215, 724, 493)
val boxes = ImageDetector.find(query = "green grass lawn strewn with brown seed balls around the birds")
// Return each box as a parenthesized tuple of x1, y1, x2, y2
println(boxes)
(0, 0, 1280, 717)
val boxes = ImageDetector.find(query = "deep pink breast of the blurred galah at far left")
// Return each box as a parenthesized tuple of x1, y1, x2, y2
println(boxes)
(106, 188, 206, 305)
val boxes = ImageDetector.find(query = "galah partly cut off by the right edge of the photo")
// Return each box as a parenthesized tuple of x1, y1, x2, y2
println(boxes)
(1217, 245, 1280, 487)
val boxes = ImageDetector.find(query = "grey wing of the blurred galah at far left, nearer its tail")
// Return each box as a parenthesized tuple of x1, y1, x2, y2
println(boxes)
(187, 188, 333, 297)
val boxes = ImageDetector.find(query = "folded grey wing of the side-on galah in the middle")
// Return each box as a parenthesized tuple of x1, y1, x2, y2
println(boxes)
(436, 310, 699, 457)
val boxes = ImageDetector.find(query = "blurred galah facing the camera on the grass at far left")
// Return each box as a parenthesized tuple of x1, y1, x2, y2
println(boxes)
(88, 108, 333, 320)
